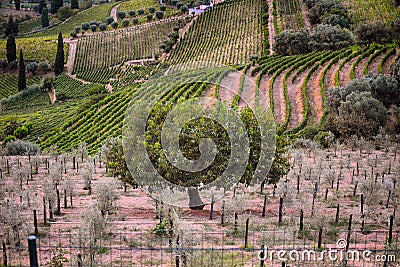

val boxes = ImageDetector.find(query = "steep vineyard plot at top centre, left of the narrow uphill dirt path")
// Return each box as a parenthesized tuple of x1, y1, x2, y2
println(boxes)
(168, 0, 269, 65)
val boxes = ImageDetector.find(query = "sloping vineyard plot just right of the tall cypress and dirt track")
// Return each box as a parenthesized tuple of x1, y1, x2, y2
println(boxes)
(73, 17, 189, 73)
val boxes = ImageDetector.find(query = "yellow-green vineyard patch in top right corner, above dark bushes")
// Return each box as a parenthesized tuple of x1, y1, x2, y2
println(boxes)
(343, 0, 400, 28)
